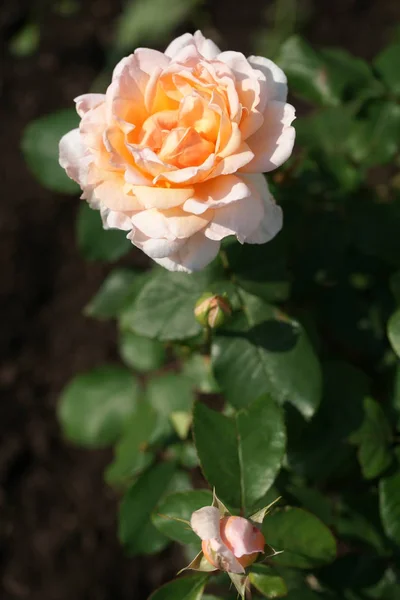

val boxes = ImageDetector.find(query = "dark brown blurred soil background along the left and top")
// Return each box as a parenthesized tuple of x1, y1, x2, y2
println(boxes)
(0, 0, 400, 600)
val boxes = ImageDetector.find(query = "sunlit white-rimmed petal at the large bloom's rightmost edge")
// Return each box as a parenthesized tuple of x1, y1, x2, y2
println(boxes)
(242, 101, 296, 173)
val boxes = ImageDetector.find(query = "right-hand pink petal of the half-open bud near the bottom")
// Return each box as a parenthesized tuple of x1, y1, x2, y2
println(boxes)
(221, 517, 265, 558)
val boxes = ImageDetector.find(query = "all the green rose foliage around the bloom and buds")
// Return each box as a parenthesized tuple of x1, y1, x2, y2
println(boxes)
(22, 0, 400, 600)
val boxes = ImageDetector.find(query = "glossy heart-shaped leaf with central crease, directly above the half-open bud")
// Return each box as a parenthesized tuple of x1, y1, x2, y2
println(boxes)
(193, 395, 286, 512)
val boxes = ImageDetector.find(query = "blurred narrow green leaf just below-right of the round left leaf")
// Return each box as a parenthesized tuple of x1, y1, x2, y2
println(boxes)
(106, 400, 157, 485)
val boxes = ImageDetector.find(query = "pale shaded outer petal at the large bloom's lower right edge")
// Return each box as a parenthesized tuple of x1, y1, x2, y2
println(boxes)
(242, 174, 283, 244)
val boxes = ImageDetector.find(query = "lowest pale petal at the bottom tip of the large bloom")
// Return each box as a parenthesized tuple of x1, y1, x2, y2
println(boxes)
(155, 231, 220, 273)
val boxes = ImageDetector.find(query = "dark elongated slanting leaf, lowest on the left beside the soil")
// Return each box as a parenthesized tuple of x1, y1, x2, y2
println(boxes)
(118, 463, 175, 552)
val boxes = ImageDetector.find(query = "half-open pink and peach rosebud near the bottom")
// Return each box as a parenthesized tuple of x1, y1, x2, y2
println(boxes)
(190, 506, 265, 573)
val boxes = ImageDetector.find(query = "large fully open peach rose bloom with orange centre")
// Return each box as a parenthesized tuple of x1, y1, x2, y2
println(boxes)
(60, 31, 295, 272)
